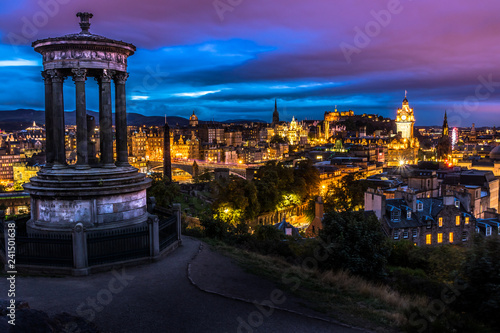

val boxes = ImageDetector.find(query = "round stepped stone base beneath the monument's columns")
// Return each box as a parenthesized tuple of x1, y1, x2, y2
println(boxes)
(24, 166, 151, 232)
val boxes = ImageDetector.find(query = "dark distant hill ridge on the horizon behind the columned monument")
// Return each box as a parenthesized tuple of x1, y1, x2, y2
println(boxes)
(0, 109, 189, 131)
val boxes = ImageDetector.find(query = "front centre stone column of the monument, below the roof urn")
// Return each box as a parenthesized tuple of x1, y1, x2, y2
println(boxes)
(71, 68, 90, 169)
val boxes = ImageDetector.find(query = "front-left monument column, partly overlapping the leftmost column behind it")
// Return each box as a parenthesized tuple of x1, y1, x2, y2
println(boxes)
(47, 69, 66, 169)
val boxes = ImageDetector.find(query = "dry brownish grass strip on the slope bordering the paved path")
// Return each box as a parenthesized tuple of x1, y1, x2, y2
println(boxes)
(205, 239, 426, 332)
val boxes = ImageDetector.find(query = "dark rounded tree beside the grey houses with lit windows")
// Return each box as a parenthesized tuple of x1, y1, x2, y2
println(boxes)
(319, 212, 390, 279)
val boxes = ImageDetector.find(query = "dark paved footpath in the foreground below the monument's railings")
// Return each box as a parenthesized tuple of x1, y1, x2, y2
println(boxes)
(0, 237, 363, 333)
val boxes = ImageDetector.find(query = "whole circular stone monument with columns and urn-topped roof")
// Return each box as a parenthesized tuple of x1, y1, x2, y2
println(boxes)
(24, 13, 151, 233)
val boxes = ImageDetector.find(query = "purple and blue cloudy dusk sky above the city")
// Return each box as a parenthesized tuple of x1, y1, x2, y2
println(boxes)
(0, 0, 500, 126)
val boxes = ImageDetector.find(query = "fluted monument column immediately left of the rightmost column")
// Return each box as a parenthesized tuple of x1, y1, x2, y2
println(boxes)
(99, 69, 116, 168)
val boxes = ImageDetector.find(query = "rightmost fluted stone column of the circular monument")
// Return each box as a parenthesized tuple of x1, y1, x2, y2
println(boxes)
(114, 72, 130, 167)
